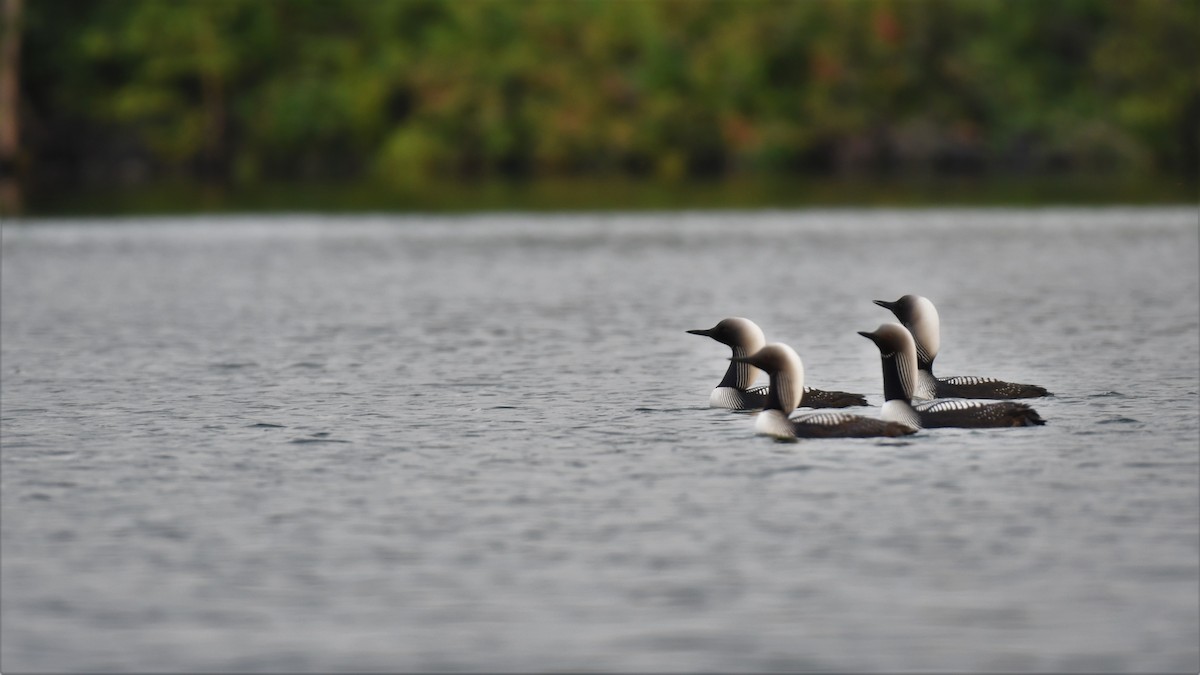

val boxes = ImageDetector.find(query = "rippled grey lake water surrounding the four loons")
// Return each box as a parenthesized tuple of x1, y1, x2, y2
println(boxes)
(0, 208, 1200, 673)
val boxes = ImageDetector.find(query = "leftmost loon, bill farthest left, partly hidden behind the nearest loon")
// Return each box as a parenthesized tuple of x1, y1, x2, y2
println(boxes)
(688, 317, 866, 410)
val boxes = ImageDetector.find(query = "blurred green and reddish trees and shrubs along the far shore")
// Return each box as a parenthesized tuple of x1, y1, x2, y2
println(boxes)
(9, 0, 1200, 195)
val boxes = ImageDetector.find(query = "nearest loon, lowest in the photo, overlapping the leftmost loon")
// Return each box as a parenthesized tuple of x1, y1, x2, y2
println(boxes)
(731, 342, 917, 440)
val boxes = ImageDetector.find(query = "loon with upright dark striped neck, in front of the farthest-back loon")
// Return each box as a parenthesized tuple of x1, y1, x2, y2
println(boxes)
(858, 323, 1045, 429)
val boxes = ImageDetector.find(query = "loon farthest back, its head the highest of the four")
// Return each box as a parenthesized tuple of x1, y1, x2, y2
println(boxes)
(875, 295, 1050, 399)
